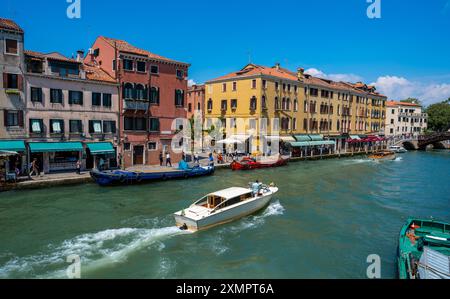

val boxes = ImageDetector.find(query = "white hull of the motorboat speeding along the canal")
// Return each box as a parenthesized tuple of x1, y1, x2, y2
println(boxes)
(174, 193, 273, 232)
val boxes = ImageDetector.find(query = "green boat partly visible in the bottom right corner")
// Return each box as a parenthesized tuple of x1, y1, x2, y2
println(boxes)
(397, 218, 450, 279)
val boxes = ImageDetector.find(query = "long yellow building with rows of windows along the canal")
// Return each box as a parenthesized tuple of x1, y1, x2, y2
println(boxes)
(205, 64, 386, 152)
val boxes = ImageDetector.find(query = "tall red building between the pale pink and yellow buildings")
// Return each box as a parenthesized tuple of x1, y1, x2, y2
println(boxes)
(85, 37, 189, 167)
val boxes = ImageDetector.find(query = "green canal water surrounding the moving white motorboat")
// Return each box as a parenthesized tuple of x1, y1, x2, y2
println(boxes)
(0, 151, 450, 278)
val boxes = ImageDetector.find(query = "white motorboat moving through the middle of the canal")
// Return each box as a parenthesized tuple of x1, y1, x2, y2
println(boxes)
(174, 184, 278, 232)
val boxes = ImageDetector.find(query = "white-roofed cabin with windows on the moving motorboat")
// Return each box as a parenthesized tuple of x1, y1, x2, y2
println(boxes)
(194, 187, 253, 210)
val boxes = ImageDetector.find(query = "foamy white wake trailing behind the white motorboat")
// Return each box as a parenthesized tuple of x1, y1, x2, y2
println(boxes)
(0, 226, 189, 278)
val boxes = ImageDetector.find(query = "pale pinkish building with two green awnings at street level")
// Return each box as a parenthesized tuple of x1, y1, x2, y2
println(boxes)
(25, 51, 119, 173)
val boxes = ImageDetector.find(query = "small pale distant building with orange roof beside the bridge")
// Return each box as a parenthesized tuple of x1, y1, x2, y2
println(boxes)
(385, 101, 428, 137)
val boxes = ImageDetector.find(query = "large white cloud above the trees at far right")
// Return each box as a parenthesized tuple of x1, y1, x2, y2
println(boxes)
(372, 76, 450, 105)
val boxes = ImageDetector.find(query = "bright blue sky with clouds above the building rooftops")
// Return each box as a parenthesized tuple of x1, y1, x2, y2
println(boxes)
(0, 0, 450, 104)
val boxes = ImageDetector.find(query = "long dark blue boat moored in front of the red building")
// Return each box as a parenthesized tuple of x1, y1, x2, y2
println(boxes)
(90, 161, 214, 186)
